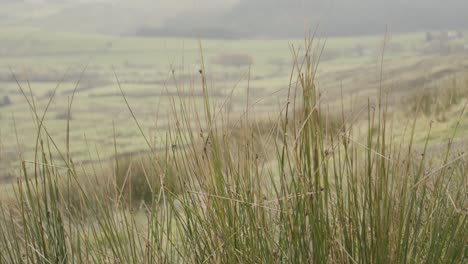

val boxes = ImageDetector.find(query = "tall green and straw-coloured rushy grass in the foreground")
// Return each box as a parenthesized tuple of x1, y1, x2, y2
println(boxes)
(0, 39, 468, 263)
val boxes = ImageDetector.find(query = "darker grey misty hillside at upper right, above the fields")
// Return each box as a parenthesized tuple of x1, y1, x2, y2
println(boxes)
(153, 0, 468, 38)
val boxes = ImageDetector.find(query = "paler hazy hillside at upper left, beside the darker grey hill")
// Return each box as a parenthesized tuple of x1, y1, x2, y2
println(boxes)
(0, 0, 234, 35)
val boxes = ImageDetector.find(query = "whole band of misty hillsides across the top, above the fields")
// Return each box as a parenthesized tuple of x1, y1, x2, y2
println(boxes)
(0, 0, 468, 38)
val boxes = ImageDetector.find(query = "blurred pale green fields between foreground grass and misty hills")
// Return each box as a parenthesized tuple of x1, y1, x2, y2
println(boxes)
(0, 26, 468, 179)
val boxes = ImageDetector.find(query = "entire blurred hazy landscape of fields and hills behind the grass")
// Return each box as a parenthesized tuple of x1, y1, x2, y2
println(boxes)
(0, 0, 468, 180)
